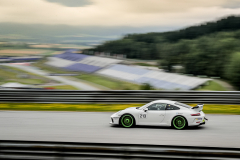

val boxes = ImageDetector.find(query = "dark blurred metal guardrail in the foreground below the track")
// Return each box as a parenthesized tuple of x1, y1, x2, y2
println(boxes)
(0, 140, 240, 160)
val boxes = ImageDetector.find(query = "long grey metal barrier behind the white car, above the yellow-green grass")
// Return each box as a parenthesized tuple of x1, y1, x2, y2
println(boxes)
(0, 90, 240, 104)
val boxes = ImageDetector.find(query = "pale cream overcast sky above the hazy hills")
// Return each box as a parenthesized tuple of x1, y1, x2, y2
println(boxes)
(0, 0, 240, 37)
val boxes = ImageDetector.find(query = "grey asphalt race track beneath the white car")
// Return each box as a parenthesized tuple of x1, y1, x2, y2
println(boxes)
(0, 111, 240, 148)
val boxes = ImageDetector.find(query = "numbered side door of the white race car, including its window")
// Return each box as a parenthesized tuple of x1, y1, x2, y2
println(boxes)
(138, 103, 166, 125)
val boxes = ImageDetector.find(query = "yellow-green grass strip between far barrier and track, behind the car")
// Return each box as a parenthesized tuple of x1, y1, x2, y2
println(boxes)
(0, 103, 240, 115)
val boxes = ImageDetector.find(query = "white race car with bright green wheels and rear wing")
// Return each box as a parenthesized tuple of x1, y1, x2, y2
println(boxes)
(110, 100, 207, 129)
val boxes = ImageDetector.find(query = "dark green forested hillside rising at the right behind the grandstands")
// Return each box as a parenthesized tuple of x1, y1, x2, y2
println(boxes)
(85, 16, 240, 89)
